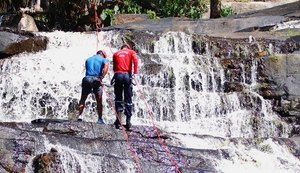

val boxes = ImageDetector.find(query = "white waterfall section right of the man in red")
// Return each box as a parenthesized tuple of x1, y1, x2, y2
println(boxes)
(136, 33, 288, 137)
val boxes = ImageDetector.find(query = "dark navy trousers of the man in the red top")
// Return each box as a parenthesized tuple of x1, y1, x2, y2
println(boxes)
(114, 73, 132, 123)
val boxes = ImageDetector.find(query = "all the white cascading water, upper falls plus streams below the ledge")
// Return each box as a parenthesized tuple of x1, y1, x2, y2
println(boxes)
(0, 31, 300, 172)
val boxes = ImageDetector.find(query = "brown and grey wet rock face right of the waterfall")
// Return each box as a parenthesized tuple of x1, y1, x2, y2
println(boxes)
(208, 35, 300, 120)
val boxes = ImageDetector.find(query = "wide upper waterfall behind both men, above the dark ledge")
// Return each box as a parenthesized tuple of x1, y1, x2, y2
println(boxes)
(0, 32, 287, 137)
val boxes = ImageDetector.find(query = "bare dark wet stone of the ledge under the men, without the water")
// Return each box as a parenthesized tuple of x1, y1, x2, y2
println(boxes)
(0, 122, 225, 173)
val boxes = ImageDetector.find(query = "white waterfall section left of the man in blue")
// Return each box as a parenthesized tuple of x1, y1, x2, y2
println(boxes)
(0, 32, 118, 122)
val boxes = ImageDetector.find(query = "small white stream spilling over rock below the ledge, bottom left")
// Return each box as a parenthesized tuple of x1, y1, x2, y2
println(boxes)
(26, 136, 136, 173)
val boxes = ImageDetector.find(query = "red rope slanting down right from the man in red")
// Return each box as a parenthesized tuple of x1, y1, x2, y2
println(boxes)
(134, 78, 181, 173)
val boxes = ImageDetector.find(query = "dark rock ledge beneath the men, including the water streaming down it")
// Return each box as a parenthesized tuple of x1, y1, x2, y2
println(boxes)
(0, 120, 220, 173)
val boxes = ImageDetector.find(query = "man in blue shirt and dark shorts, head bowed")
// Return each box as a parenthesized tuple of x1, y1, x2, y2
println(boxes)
(78, 50, 108, 124)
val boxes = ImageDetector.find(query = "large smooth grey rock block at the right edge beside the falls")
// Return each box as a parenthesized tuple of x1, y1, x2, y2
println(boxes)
(262, 54, 300, 118)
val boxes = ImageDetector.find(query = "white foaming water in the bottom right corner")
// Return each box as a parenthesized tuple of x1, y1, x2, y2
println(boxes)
(218, 139, 300, 173)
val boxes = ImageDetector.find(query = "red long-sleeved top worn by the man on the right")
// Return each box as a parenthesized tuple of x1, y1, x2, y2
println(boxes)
(113, 48, 138, 74)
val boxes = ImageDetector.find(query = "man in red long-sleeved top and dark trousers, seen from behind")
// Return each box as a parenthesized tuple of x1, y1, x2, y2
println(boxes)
(113, 44, 138, 130)
